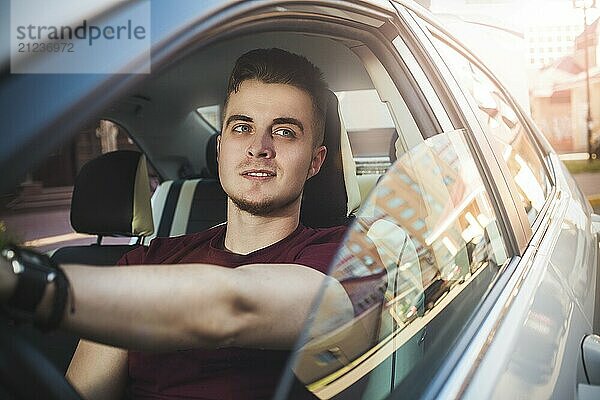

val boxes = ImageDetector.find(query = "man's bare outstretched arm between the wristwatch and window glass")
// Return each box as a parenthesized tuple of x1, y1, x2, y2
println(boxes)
(27, 264, 342, 351)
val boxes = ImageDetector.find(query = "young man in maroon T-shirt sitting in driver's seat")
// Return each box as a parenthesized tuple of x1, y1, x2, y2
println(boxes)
(0, 49, 353, 399)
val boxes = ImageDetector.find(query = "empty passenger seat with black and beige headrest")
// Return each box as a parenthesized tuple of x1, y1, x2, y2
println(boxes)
(18, 150, 154, 372)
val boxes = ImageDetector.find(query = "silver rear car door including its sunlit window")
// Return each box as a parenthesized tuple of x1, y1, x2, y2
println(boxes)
(398, 4, 597, 398)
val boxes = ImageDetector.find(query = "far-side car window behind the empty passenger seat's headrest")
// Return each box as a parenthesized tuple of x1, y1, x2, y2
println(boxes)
(0, 120, 159, 252)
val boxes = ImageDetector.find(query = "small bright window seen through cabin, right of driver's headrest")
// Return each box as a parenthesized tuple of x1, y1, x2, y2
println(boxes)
(335, 89, 398, 175)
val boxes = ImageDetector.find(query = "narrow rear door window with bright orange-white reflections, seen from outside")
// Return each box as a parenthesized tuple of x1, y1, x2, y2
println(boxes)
(434, 40, 550, 225)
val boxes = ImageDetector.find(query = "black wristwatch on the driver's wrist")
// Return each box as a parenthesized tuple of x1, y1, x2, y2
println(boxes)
(0, 245, 68, 330)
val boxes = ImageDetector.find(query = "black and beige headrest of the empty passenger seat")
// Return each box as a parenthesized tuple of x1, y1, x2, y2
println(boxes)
(71, 150, 154, 236)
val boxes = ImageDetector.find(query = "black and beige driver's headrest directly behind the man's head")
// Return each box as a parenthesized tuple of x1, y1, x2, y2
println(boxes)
(300, 92, 360, 228)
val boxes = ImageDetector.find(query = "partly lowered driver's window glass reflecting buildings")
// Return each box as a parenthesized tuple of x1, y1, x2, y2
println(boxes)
(293, 131, 507, 399)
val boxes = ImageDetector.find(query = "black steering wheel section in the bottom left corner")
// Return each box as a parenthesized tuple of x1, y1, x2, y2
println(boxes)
(0, 316, 82, 400)
